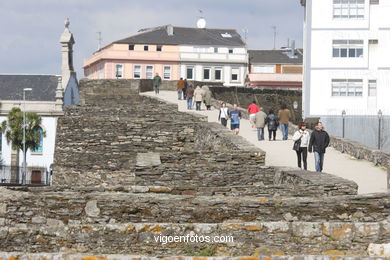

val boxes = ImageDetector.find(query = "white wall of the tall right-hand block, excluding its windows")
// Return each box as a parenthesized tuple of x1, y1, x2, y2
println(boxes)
(303, 0, 390, 117)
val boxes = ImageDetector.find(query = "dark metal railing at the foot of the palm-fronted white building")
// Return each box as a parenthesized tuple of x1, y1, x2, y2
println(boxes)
(0, 165, 50, 186)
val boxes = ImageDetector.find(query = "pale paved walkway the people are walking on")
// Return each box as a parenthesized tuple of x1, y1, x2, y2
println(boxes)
(142, 91, 387, 194)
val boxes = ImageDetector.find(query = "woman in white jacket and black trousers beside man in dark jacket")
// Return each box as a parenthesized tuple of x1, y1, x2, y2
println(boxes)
(292, 122, 310, 170)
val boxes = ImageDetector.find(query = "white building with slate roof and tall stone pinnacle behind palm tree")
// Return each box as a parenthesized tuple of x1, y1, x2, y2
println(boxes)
(0, 20, 79, 183)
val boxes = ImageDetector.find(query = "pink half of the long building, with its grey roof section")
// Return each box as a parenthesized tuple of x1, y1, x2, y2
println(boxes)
(83, 27, 180, 80)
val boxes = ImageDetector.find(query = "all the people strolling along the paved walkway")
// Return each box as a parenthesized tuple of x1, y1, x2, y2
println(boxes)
(153, 73, 330, 172)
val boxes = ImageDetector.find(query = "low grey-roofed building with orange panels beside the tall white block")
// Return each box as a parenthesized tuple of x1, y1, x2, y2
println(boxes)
(248, 48, 303, 90)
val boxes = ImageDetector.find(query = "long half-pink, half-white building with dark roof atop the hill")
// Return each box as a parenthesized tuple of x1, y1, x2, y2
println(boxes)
(84, 25, 248, 86)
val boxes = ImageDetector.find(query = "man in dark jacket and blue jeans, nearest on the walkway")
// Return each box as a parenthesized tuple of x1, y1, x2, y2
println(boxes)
(309, 122, 330, 172)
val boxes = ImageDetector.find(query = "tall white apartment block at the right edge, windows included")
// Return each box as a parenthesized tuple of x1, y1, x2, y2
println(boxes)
(301, 0, 390, 117)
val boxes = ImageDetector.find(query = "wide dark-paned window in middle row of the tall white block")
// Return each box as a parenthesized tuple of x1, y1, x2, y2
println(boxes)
(333, 40, 364, 58)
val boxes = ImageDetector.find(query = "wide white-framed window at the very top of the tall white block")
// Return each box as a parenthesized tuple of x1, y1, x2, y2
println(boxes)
(333, 0, 364, 19)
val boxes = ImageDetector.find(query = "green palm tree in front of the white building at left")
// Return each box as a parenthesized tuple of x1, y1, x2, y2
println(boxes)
(1, 107, 46, 182)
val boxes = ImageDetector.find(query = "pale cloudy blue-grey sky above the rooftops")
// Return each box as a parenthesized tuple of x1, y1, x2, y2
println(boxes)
(0, 0, 303, 79)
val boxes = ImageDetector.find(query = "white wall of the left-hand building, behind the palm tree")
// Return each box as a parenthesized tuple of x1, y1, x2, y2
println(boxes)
(0, 116, 57, 169)
